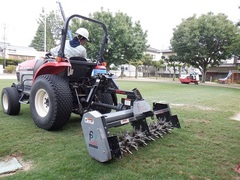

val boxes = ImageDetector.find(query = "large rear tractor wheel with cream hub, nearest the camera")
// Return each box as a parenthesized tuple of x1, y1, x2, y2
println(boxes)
(30, 74, 72, 130)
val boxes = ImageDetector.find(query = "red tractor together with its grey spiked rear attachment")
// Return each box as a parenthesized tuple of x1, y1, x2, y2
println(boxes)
(1, 14, 180, 162)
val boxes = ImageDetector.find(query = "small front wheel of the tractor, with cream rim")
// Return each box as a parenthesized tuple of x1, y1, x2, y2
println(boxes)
(1, 87, 20, 115)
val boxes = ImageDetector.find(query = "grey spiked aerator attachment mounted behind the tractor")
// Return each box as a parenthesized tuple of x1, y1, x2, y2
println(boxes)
(81, 89, 181, 162)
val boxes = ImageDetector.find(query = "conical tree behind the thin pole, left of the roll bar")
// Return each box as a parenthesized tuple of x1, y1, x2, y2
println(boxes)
(30, 11, 64, 51)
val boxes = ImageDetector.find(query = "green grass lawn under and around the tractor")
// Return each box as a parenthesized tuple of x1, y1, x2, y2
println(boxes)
(0, 80, 240, 180)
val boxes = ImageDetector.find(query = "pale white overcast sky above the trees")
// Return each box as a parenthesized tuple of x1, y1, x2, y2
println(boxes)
(0, 0, 240, 50)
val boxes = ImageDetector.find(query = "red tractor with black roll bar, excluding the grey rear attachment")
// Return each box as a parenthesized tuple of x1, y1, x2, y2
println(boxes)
(1, 14, 118, 130)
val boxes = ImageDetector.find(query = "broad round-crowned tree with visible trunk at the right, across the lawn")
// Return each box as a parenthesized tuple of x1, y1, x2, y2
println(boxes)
(171, 12, 238, 82)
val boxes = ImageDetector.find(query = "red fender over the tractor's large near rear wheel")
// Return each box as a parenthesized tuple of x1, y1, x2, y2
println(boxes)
(33, 61, 71, 81)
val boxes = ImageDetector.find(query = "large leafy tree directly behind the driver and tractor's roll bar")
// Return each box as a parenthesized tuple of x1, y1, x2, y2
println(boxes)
(71, 9, 147, 67)
